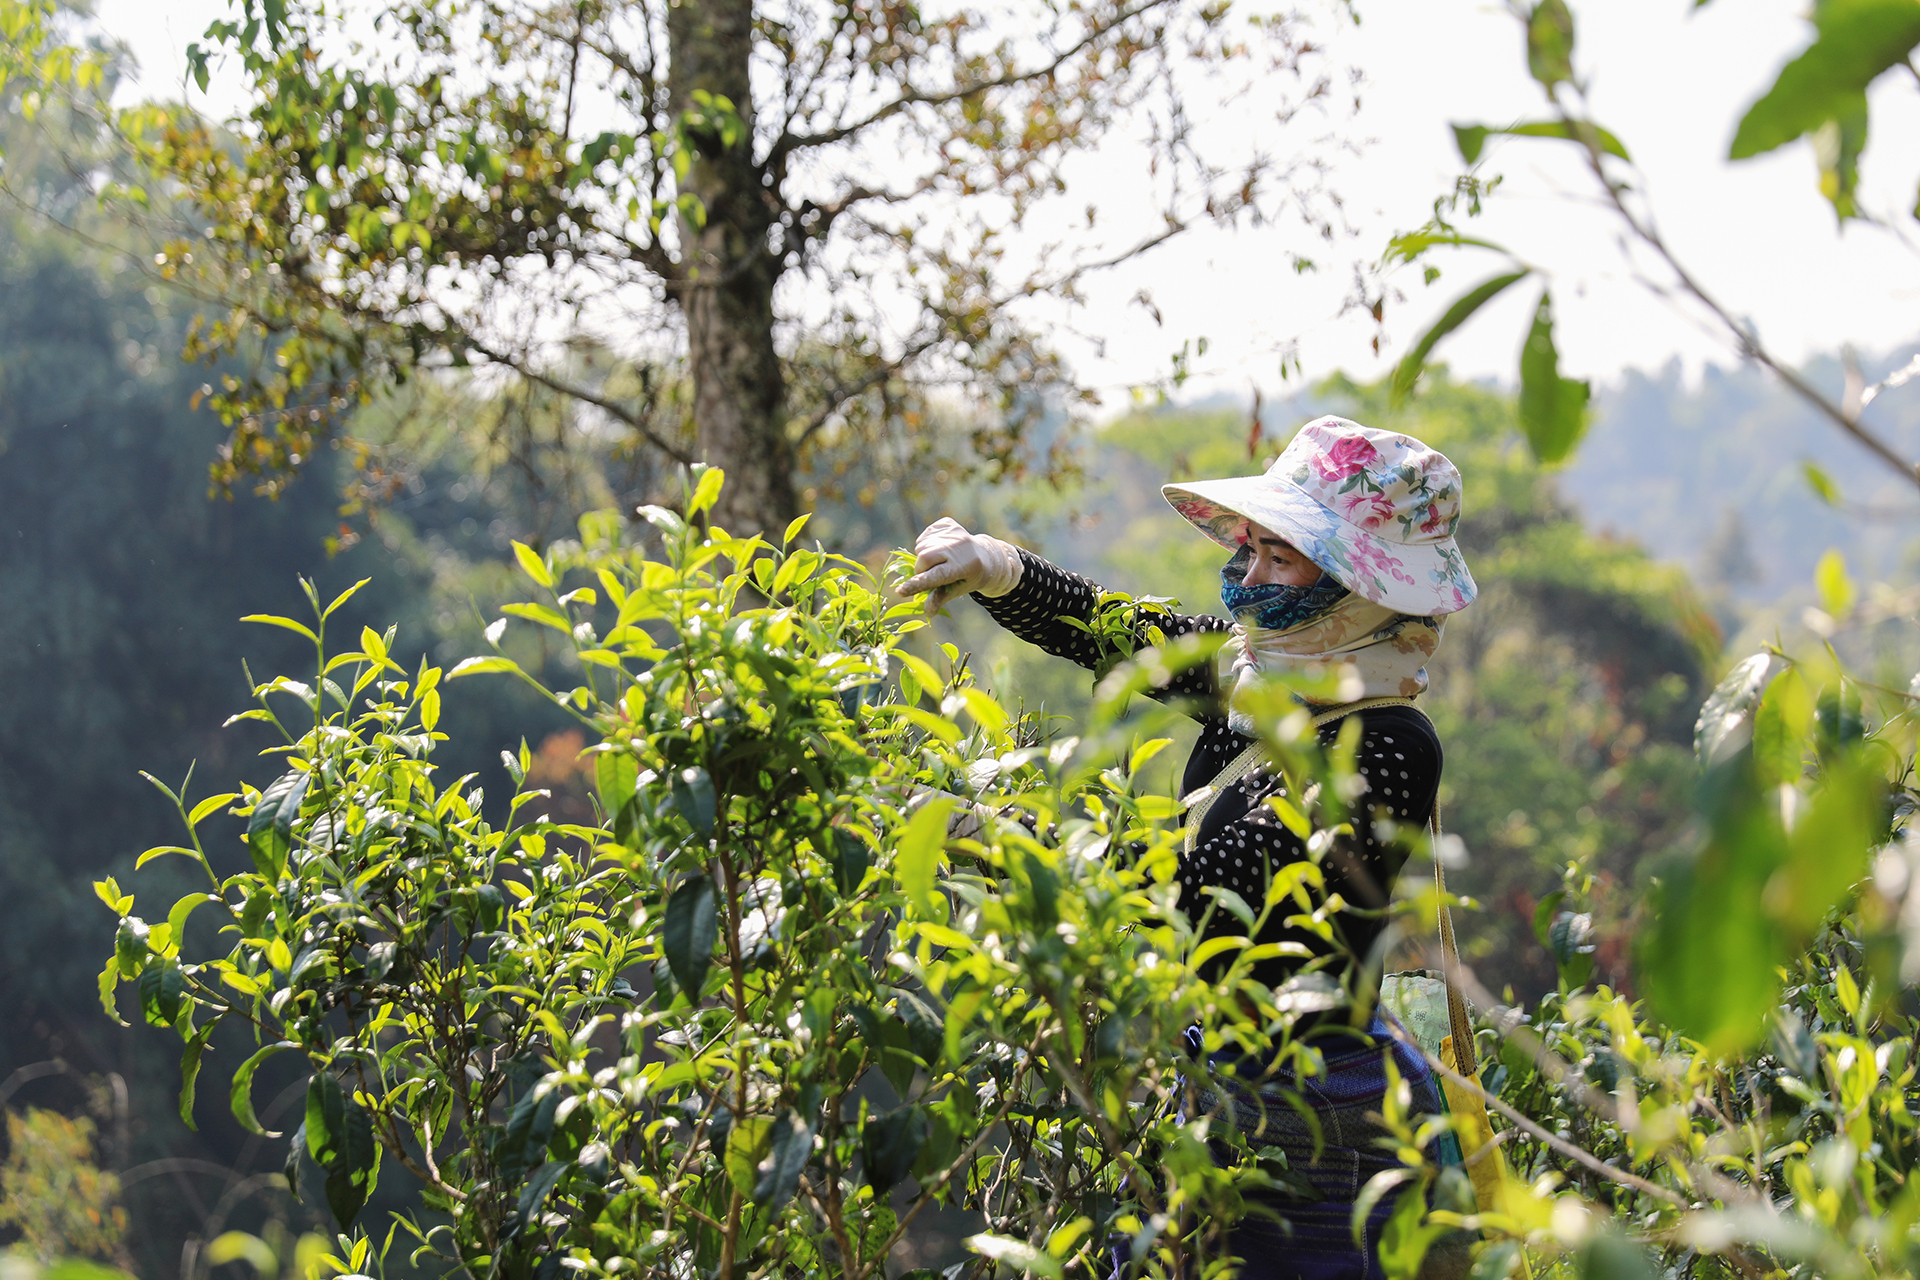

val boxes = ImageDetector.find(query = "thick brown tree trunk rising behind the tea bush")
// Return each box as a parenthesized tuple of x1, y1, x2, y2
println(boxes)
(666, 0, 801, 537)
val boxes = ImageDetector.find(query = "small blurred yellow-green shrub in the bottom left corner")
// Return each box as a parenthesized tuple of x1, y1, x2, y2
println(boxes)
(0, 1107, 127, 1274)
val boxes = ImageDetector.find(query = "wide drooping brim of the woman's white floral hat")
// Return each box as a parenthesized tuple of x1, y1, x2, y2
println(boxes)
(1160, 474, 1478, 618)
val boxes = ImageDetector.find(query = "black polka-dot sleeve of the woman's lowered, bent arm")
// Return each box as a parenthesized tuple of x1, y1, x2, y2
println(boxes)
(1181, 708, 1440, 986)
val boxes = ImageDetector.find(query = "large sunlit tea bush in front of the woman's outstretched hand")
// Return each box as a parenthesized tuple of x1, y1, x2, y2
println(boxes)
(100, 470, 1413, 1276)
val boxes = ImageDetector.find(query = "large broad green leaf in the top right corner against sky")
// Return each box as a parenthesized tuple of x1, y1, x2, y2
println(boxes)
(1728, 0, 1920, 159)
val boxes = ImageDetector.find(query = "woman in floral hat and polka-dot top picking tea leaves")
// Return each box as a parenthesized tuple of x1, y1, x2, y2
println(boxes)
(900, 418, 1475, 1280)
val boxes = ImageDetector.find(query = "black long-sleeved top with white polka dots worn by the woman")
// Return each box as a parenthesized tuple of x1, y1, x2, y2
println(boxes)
(973, 551, 1440, 986)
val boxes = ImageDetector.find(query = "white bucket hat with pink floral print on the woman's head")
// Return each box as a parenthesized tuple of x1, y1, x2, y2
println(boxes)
(1160, 418, 1478, 618)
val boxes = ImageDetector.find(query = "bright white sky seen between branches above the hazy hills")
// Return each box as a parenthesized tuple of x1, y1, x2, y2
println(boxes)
(98, 0, 1920, 405)
